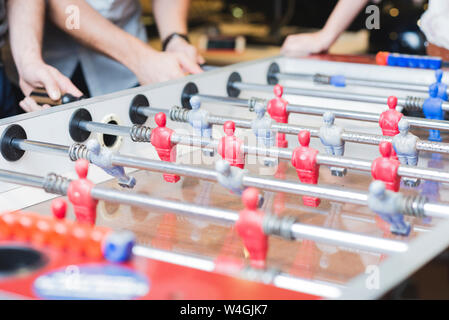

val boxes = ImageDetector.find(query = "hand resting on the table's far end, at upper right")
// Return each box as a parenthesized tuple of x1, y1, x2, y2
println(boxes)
(281, 31, 332, 57)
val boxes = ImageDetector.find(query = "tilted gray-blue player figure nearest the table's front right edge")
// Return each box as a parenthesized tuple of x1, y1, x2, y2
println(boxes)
(368, 180, 411, 236)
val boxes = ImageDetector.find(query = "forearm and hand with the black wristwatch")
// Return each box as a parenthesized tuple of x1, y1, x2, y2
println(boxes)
(153, 0, 205, 64)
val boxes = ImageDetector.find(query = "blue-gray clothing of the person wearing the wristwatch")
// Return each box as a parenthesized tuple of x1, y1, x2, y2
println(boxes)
(43, 0, 147, 96)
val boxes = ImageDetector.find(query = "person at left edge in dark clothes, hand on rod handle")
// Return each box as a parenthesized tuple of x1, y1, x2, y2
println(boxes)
(4, 0, 82, 117)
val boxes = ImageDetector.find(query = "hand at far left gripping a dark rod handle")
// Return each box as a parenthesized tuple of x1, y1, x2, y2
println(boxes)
(19, 61, 83, 112)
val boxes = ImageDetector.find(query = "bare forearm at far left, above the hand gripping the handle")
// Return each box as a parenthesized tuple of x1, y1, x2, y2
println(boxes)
(7, 0, 45, 74)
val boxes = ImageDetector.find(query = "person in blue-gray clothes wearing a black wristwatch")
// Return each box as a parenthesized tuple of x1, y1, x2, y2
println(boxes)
(20, 0, 204, 111)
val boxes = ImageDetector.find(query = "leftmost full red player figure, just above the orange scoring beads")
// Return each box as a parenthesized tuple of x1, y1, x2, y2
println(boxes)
(67, 159, 98, 225)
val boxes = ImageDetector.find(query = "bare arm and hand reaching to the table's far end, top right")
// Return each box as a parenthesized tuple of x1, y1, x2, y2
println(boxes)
(281, 0, 369, 56)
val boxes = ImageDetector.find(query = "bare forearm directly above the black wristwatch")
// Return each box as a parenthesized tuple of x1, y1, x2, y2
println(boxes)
(153, 0, 190, 39)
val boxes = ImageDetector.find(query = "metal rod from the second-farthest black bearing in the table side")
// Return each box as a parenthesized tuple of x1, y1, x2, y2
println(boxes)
(232, 82, 449, 111)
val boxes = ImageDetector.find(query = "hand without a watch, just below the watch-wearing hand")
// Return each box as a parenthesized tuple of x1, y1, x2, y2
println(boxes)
(133, 47, 202, 85)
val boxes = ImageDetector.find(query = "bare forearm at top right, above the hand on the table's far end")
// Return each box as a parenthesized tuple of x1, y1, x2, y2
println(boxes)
(323, 0, 369, 43)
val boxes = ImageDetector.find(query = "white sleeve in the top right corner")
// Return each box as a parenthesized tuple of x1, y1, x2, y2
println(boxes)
(421, 0, 449, 50)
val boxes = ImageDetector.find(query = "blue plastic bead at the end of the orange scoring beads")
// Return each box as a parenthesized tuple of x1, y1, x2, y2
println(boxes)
(103, 231, 136, 263)
